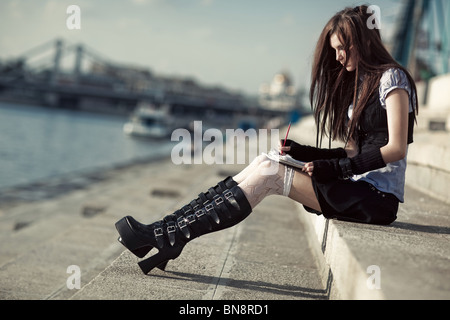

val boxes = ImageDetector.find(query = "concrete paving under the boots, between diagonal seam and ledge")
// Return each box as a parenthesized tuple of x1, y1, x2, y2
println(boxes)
(72, 188, 328, 300)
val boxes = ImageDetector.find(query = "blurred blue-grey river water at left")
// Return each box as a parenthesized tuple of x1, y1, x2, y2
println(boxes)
(0, 102, 173, 189)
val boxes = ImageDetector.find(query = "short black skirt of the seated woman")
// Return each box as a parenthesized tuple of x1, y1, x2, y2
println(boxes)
(305, 177, 399, 225)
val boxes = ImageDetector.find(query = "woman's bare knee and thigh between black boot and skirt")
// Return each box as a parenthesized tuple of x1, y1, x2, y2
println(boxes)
(237, 155, 320, 211)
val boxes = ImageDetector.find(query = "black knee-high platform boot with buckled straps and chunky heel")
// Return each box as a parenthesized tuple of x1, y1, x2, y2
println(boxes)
(116, 177, 252, 274)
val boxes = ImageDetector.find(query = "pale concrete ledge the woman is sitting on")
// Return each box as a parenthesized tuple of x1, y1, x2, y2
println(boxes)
(298, 185, 450, 300)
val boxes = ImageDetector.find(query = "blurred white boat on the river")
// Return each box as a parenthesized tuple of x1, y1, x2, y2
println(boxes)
(123, 105, 171, 138)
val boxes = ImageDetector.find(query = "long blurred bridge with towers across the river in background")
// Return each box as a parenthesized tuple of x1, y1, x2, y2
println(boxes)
(0, 39, 298, 129)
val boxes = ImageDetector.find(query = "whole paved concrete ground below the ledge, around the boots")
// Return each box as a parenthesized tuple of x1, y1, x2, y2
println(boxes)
(0, 149, 326, 299)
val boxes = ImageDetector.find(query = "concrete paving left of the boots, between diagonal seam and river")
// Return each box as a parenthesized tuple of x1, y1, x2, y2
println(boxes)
(0, 161, 230, 299)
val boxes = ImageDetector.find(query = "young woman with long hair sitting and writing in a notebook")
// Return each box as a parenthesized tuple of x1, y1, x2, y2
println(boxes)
(116, 6, 418, 273)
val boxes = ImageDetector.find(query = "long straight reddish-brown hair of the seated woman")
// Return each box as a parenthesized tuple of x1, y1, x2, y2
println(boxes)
(309, 5, 418, 142)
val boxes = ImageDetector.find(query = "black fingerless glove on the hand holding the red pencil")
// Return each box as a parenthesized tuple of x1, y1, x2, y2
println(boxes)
(281, 139, 347, 162)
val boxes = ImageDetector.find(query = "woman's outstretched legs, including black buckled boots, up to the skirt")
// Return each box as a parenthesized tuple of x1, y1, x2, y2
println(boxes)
(116, 156, 320, 273)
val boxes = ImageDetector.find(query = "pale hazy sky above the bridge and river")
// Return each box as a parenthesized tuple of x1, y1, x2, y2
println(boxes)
(0, 0, 402, 94)
